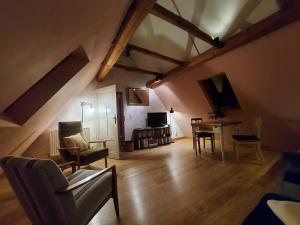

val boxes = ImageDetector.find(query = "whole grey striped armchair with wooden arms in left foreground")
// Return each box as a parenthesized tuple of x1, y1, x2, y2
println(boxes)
(0, 156, 119, 225)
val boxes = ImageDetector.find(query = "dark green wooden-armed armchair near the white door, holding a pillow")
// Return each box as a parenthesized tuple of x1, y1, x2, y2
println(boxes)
(58, 121, 108, 169)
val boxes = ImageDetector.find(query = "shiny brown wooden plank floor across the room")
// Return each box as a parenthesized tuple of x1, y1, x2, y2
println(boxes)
(0, 139, 286, 225)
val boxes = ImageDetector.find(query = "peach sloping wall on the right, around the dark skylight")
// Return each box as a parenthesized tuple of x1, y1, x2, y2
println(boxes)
(155, 21, 300, 151)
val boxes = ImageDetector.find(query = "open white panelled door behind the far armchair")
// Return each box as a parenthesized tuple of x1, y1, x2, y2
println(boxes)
(96, 85, 119, 159)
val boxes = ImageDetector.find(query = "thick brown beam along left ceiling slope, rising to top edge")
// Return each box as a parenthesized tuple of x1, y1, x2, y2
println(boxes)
(97, 0, 157, 81)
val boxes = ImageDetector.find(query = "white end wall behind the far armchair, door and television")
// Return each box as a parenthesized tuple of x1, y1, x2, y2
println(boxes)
(25, 69, 183, 158)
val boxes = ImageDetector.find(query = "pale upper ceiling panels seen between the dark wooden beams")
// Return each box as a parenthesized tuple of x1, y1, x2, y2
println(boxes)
(120, 0, 279, 73)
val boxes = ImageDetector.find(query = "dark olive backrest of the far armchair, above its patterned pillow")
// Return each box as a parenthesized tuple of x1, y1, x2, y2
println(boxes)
(58, 121, 83, 148)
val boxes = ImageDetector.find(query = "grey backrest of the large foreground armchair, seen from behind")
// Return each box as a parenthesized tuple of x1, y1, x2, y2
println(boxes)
(0, 156, 76, 225)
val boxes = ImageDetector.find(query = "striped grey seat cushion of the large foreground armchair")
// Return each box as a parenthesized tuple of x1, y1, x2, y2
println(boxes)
(68, 170, 112, 224)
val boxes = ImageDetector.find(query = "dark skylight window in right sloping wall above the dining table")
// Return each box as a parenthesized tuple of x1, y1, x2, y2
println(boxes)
(198, 73, 240, 109)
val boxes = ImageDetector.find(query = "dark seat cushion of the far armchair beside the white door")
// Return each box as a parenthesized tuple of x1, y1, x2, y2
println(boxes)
(67, 148, 108, 165)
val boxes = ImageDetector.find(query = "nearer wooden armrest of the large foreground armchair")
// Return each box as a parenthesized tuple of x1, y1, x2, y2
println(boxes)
(55, 166, 116, 194)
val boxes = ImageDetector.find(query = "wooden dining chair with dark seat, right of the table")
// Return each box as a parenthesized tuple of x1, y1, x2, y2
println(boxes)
(232, 117, 265, 164)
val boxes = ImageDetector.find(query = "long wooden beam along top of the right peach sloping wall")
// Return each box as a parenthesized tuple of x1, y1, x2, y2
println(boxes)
(146, 2, 300, 88)
